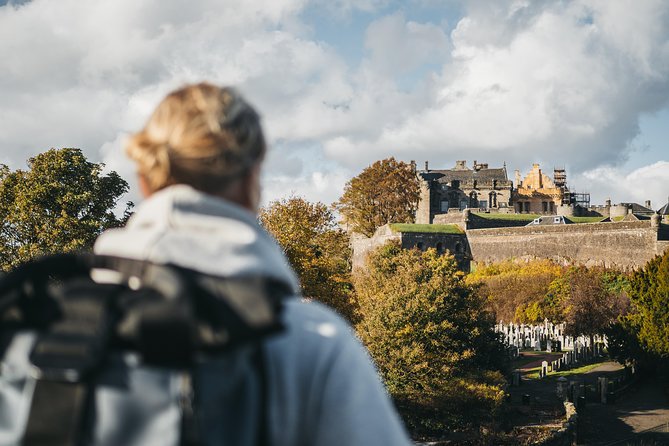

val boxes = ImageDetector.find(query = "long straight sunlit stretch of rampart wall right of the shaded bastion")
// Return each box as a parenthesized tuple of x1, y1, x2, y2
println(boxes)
(467, 221, 667, 270)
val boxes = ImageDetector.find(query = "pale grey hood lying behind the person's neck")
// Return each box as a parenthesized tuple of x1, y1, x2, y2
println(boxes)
(95, 185, 300, 294)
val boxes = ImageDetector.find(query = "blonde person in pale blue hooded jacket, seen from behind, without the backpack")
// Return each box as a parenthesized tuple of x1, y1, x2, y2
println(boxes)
(93, 83, 410, 446)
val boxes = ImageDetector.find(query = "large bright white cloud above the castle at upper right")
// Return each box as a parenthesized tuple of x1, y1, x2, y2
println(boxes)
(318, 1, 669, 171)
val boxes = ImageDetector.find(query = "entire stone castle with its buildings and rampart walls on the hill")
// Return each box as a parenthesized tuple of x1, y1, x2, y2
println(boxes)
(352, 161, 669, 270)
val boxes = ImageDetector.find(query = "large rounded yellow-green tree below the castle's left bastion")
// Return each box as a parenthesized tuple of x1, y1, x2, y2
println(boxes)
(354, 243, 504, 437)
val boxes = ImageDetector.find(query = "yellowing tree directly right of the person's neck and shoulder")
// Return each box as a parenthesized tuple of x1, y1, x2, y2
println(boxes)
(260, 197, 356, 322)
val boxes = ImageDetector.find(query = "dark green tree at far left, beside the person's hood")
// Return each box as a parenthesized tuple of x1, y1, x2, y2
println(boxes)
(0, 149, 132, 271)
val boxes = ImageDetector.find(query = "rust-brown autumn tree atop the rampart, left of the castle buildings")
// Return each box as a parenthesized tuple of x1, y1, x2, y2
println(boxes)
(335, 158, 420, 237)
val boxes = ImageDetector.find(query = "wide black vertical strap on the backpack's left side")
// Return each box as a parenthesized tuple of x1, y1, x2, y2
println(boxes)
(23, 280, 118, 446)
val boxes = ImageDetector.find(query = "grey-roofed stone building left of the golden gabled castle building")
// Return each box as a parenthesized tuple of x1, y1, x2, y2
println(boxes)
(416, 161, 513, 224)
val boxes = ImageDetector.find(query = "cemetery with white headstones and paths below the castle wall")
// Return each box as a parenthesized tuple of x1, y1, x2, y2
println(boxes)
(495, 321, 660, 445)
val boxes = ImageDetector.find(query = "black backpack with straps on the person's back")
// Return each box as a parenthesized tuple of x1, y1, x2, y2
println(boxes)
(0, 254, 291, 446)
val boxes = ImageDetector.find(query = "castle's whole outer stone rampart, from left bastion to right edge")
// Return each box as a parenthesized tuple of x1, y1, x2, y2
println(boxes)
(353, 216, 669, 271)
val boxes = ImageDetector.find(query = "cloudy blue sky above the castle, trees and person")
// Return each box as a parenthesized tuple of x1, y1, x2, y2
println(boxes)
(0, 0, 669, 209)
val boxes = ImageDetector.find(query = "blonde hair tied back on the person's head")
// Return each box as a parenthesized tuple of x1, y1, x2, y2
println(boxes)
(126, 83, 265, 194)
